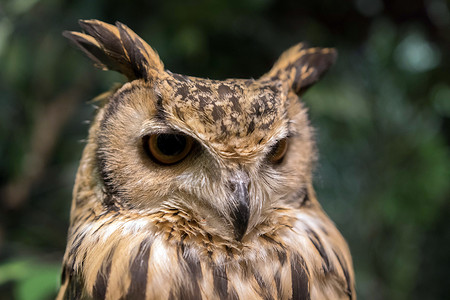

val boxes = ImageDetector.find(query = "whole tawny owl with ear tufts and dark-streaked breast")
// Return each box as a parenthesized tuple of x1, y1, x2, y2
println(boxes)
(57, 20, 356, 299)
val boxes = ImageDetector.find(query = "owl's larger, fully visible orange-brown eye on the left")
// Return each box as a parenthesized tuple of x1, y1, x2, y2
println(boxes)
(144, 134, 193, 165)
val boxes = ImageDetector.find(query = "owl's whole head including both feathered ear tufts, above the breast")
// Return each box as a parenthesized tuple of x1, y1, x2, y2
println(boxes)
(65, 20, 336, 241)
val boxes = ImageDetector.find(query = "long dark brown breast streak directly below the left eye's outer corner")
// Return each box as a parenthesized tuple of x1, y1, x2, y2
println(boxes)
(125, 238, 153, 299)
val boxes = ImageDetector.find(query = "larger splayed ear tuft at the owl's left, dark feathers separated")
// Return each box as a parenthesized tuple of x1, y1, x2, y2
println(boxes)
(63, 20, 164, 80)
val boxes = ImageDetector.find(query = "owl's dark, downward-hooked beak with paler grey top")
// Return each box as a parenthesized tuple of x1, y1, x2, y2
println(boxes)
(229, 177, 250, 241)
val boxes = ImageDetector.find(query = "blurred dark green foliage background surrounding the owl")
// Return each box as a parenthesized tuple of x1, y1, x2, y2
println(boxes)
(0, 0, 450, 300)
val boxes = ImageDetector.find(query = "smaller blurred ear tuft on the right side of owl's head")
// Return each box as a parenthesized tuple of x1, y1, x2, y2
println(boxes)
(262, 43, 337, 94)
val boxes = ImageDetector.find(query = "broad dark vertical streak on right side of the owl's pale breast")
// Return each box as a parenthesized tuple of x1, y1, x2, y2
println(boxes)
(291, 256, 311, 300)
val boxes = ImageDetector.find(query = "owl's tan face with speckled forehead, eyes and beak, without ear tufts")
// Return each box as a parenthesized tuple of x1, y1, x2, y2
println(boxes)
(97, 73, 312, 239)
